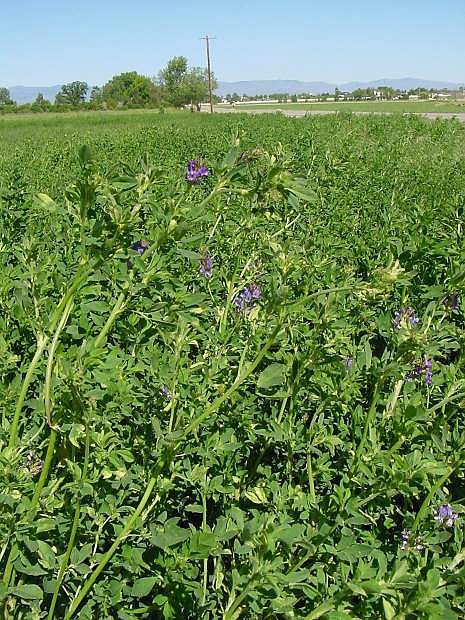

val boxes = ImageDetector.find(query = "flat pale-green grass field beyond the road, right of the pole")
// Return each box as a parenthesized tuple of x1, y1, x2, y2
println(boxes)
(218, 101, 465, 114)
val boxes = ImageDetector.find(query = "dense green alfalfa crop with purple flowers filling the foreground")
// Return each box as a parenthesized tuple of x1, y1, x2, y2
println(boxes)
(0, 114, 465, 620)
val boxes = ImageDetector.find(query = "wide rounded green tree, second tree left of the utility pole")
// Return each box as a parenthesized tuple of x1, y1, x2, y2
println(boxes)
(99, 71, 159, 105)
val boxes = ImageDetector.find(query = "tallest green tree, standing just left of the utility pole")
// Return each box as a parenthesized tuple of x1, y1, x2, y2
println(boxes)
(159, 56, 216, 107)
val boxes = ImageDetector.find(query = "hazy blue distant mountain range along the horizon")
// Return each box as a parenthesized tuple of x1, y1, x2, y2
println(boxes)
(9, 78, 465, 103)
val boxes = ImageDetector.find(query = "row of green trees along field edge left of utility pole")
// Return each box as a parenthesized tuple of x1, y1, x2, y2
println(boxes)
(0, 56, 216, 111)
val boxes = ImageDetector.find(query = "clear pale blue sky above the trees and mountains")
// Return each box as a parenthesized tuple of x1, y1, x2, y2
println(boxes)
(0, 0, 465, 86)
